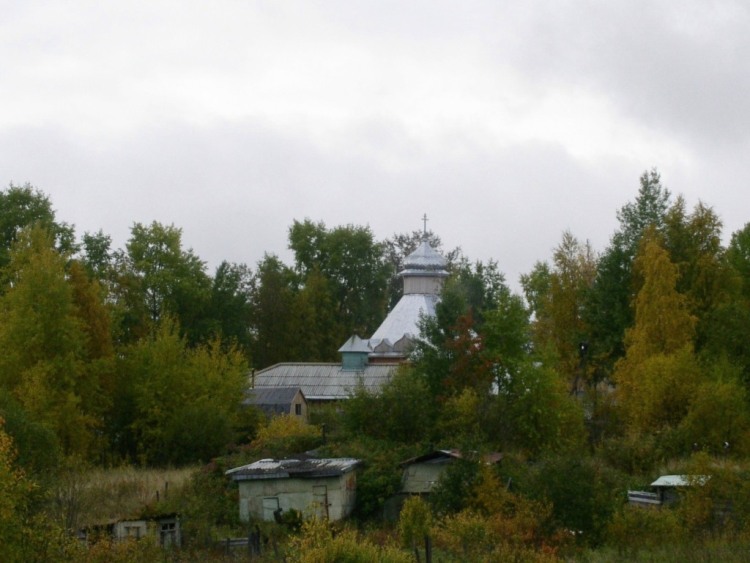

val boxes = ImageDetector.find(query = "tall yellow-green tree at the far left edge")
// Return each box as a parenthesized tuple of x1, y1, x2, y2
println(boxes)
(0, 227, 100, 455)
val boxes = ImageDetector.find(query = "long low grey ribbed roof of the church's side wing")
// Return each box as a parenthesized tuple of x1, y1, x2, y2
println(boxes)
(255, 362, 399, 401)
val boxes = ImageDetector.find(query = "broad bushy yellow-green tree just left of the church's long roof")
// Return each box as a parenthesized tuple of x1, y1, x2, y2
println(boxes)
(115, 318, 247, 464)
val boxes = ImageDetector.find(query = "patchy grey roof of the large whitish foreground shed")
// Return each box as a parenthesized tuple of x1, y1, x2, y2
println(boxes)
(225, 458, 359, 481)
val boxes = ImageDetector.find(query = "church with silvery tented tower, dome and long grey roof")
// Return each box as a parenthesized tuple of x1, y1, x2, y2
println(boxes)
(251, 227, 448, 403)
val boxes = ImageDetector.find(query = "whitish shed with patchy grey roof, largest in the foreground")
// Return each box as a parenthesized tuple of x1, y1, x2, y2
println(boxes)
(226, 456, 359, 522)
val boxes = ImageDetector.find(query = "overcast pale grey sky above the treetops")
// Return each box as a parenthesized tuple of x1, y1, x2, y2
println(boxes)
(0, 0, 750, 287)
